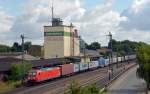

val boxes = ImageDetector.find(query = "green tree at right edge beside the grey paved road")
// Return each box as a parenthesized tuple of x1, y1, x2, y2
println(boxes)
(137, 43, 150, 89)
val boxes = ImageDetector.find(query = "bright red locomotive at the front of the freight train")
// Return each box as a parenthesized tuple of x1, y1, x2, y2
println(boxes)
(28, 67, 61, 82)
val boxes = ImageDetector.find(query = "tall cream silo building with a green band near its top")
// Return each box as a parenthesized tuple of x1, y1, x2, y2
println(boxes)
(44, 20, 80, 59)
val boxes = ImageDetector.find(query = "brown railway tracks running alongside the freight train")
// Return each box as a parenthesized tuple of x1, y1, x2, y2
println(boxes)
(2, 60, 136, 94)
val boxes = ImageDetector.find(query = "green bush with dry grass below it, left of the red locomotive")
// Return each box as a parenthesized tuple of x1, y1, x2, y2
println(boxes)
(0, 61, 32, 93)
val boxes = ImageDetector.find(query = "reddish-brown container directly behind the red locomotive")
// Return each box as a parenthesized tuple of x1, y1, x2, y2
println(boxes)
(60, 63, 74, 76)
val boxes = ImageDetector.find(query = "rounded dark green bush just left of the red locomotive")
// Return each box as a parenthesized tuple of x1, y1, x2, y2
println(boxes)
(7, 61, 32, 81)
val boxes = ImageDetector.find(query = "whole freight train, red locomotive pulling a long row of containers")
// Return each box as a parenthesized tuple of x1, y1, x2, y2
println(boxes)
(27, 55, 136, 82)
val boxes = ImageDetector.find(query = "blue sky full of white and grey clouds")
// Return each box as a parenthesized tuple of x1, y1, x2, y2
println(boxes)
(0, 0, 150, 45)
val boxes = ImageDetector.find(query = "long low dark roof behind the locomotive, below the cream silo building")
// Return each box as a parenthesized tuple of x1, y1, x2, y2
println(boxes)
(0, 57, 79, 71)
